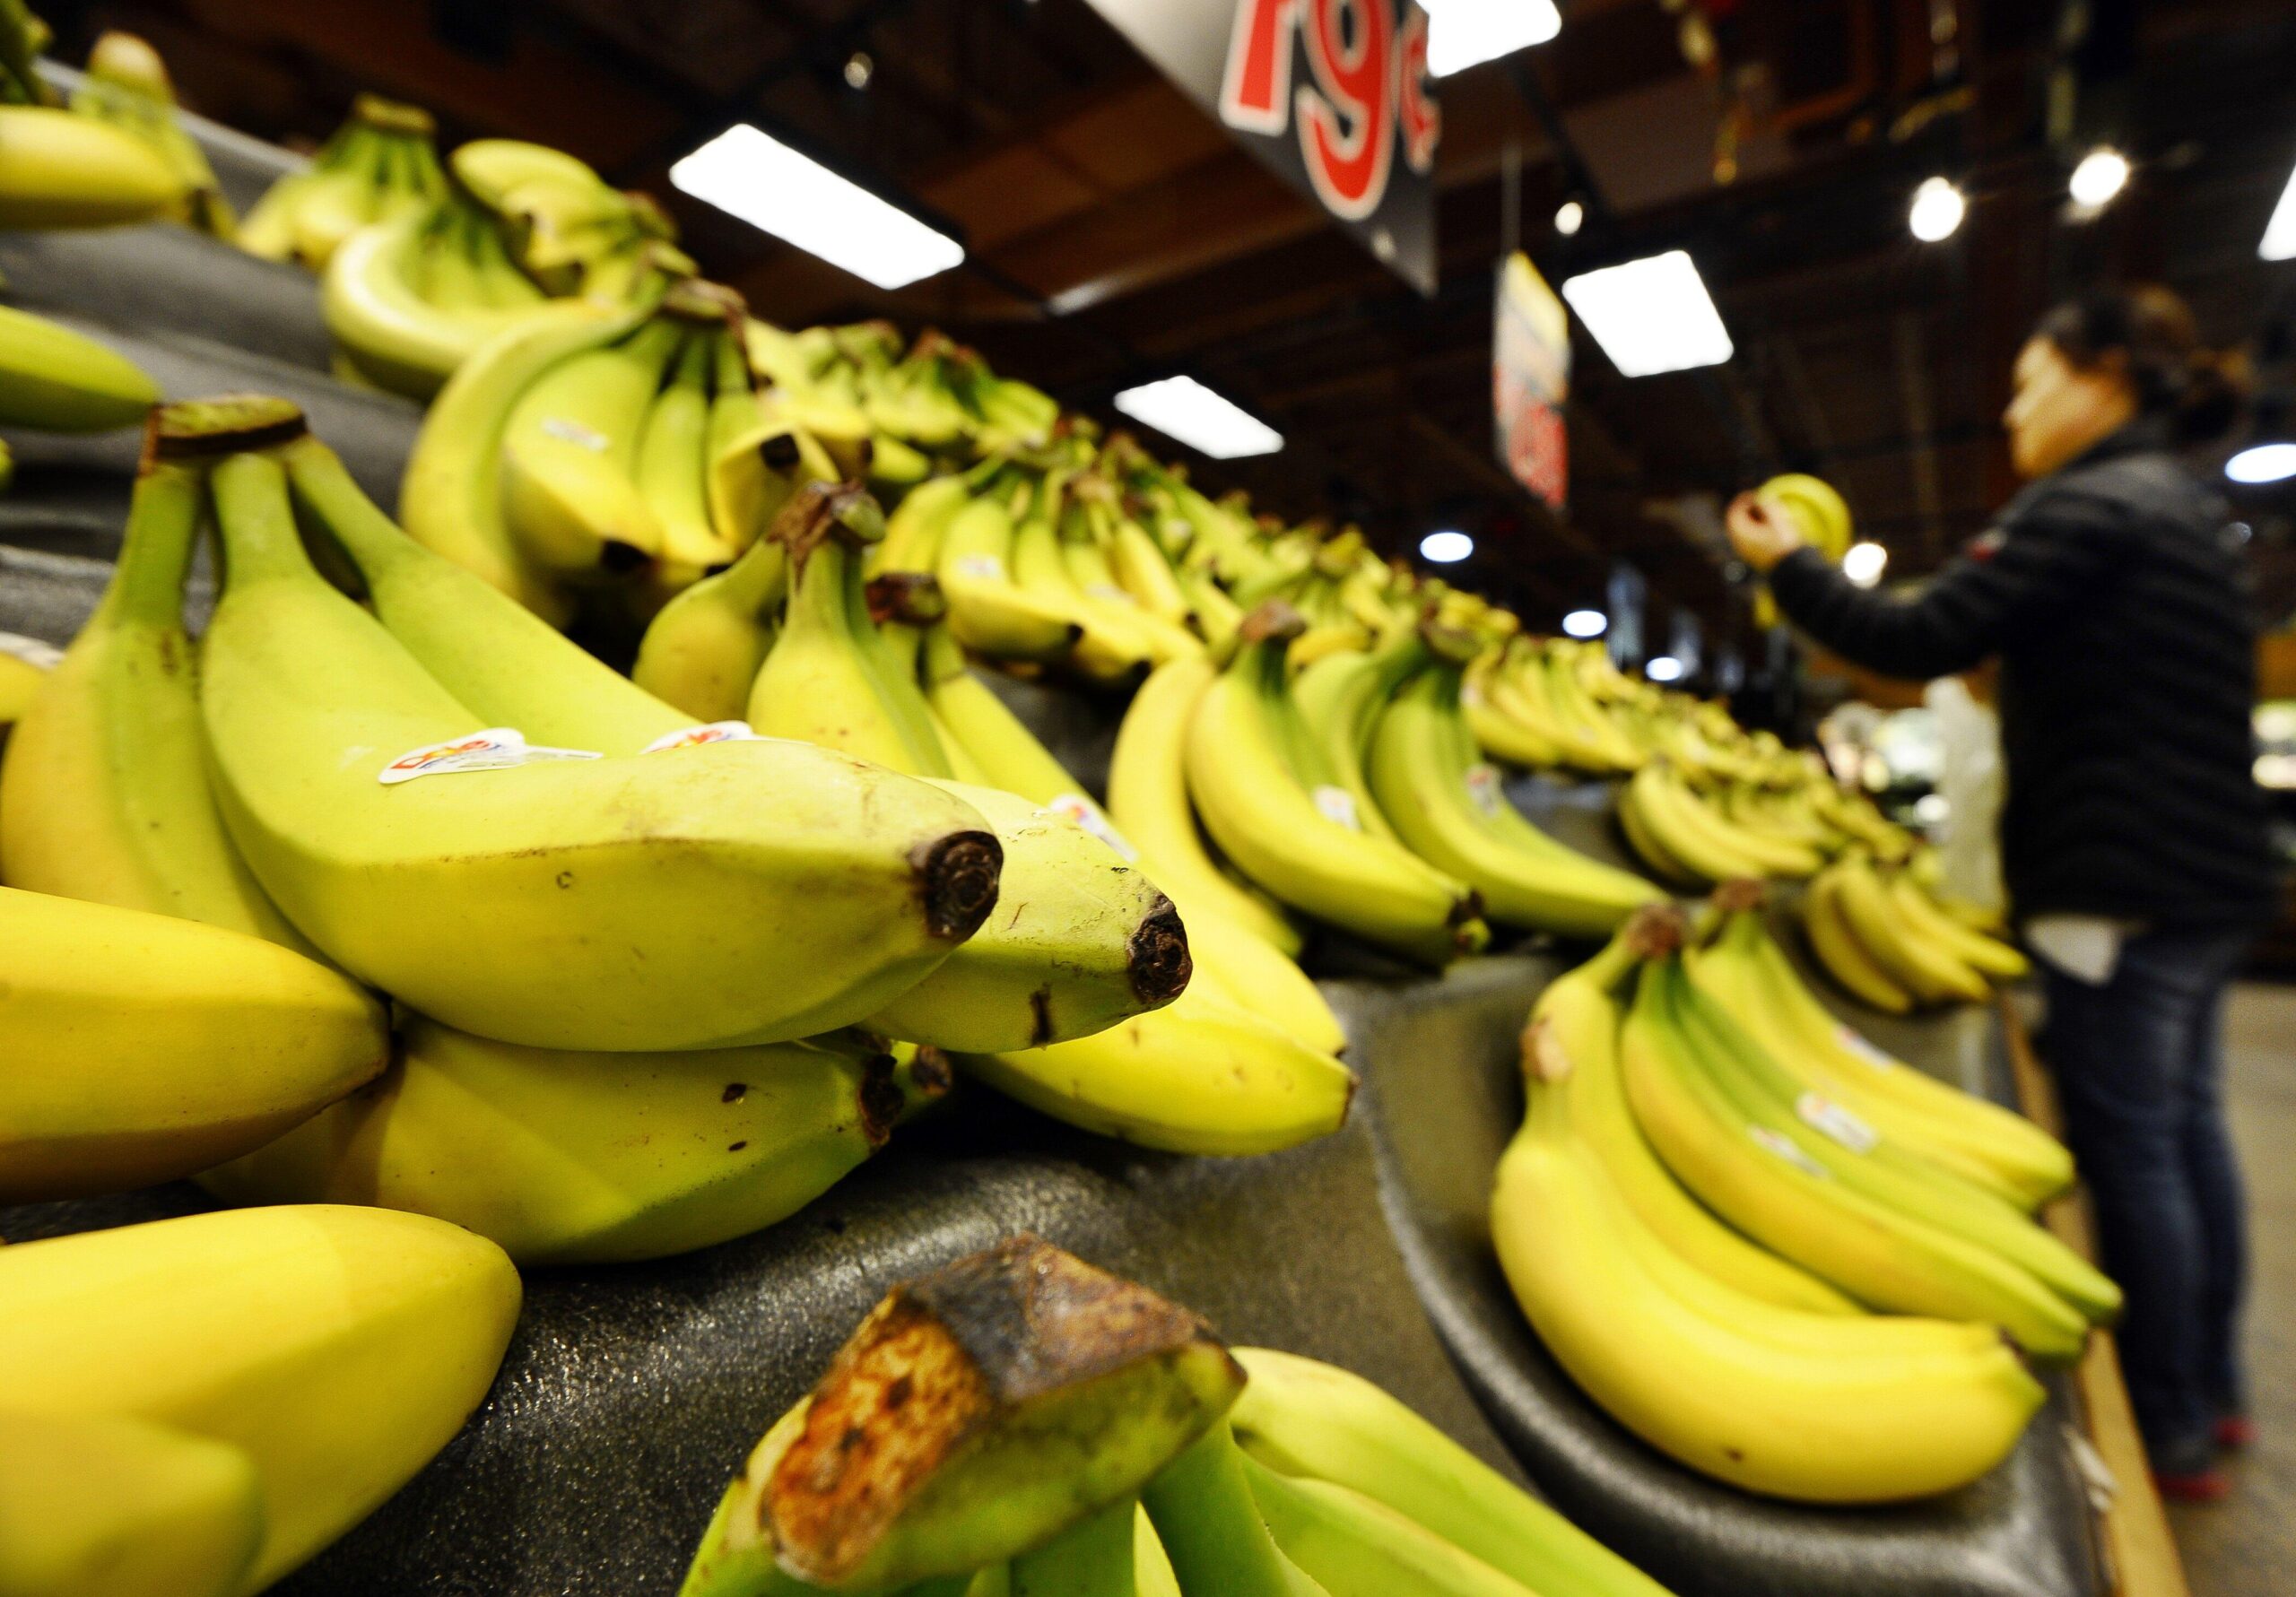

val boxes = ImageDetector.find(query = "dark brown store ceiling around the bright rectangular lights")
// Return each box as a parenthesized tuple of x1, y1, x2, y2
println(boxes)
(39, 0, 2296, 670)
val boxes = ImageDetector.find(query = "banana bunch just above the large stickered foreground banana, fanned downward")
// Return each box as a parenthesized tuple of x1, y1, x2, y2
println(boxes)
(399, 280, 817, 624)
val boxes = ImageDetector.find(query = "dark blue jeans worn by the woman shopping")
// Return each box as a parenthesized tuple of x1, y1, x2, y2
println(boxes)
(2041, 929, 2252, 1473)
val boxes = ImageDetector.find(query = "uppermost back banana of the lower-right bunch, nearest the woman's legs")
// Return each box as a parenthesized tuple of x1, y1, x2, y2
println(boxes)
(1685, 908, 2074, 1210)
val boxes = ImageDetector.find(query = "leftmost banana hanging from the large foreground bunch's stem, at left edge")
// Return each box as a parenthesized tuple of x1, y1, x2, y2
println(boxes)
(0, 436, 310, 952)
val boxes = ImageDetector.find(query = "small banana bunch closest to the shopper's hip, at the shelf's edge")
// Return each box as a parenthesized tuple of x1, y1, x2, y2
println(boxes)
(1803, 845, 2030, 1014)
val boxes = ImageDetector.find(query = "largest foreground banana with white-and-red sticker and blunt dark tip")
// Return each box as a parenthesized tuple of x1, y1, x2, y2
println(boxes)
(202, 417, 999, 1048)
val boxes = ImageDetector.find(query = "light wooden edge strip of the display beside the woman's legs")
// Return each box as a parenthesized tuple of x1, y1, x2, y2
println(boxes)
(1997, 994, 2193, 1597)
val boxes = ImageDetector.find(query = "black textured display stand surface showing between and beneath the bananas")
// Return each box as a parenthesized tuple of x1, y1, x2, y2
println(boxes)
(0, 215, 2149, 1597)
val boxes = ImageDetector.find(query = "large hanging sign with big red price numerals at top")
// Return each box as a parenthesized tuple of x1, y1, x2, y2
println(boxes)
(1093, 0, 1442, 294)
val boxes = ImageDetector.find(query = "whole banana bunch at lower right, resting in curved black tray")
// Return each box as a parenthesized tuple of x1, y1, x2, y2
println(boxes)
(1492, 907, 2119, 1503)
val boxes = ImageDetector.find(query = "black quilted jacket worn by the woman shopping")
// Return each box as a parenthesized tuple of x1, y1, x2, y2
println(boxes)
(1770, 422, 2278, 924)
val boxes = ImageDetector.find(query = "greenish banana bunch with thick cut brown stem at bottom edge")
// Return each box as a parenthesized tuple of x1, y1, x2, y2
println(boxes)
(680, 1237, 1665, 1597)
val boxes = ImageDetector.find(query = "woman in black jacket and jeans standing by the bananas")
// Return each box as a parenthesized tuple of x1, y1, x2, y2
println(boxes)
(1729, 287, 2275, 1498)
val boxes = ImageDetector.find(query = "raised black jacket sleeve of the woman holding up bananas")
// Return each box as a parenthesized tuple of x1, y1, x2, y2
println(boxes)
(1770, 496, 2126, 681)
